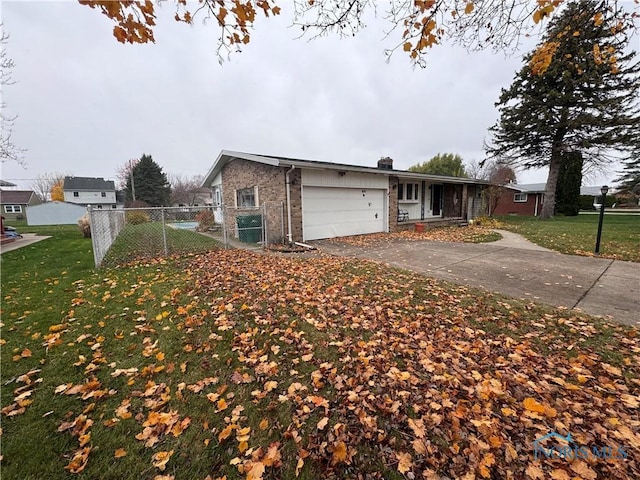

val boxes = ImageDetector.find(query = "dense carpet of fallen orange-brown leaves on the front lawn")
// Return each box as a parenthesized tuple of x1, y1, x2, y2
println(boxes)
(11, 249, 640, 480)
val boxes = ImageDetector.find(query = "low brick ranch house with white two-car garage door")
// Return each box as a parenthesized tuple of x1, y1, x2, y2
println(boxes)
(202, 150, 486, 242)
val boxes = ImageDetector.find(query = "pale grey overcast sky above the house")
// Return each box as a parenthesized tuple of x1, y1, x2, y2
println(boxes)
(0, 0, 632, 191)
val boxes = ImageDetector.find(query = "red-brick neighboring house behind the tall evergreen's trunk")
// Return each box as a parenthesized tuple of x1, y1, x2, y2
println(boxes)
(491, 183, 601, 217)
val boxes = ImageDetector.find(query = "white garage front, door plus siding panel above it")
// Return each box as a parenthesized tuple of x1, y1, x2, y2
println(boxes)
(302, 170, 388, 241)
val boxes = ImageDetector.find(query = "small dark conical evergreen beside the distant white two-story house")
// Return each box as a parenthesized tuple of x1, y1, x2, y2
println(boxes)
(125, 154, 171, 207)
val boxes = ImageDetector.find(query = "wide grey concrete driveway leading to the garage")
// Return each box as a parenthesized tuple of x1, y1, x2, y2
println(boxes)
(314, 232, 640, 326)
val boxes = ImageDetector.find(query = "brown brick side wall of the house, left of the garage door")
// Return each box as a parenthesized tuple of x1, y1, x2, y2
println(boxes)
(222, 159, 302, 243)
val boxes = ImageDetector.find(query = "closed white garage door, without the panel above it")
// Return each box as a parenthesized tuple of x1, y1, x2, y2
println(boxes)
(302, 186, 386, 240)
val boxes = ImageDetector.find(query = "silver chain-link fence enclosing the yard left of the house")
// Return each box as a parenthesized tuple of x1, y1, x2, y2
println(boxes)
(88, 204, 284, 267)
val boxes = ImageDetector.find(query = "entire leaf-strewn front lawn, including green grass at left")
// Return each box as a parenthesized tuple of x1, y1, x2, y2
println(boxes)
(1, 230, 640, 480)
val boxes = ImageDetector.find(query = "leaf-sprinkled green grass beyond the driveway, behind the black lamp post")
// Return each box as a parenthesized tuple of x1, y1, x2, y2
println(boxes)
(498, 214, 640, 262)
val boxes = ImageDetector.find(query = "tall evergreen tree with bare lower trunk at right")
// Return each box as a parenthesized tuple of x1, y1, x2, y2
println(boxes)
(487, 0, 640, 218)
